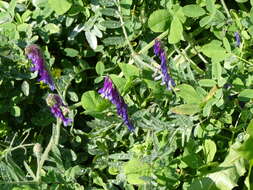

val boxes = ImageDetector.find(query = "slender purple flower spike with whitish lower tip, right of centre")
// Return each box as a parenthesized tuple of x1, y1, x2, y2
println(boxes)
(153, 40, 176, 90)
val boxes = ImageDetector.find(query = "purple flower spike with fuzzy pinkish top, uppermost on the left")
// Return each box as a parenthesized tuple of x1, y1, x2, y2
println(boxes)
(25, 44, 55, 91)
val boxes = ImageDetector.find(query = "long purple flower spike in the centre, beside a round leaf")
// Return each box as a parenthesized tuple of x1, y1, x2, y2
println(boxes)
(98, 77, 134, 131)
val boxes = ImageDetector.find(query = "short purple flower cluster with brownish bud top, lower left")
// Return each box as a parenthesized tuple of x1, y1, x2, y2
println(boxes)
(46, 94, 73, 126)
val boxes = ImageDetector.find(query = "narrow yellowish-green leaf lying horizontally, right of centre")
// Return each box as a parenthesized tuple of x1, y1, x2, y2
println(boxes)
(170, 104, 201, 115)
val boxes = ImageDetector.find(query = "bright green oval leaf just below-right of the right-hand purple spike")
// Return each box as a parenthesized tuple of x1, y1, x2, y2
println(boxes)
(176, 84, 202, 104)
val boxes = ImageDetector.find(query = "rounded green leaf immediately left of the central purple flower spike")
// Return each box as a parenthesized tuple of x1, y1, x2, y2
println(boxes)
(81, 91, 110, 112)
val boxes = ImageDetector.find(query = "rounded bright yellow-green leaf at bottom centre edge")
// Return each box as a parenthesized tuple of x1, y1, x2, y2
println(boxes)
(123, 159, 151, 185)
